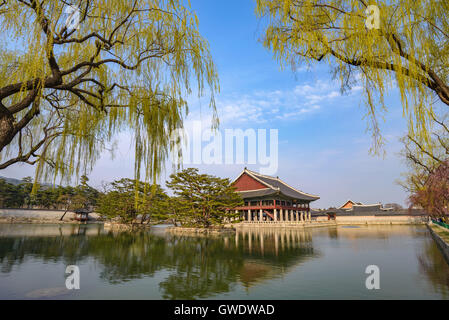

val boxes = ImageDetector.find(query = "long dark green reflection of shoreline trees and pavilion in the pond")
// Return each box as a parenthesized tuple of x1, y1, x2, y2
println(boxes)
(0, 225, 320, 299)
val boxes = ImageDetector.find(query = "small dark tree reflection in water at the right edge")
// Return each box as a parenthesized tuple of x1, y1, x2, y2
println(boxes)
(417, 239, 449, 299)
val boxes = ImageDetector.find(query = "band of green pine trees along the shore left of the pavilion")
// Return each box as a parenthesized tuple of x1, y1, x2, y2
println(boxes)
(0, 168, 243, 228)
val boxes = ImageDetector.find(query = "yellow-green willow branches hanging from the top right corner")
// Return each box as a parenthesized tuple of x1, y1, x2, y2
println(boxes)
(256, 0, 449, 152)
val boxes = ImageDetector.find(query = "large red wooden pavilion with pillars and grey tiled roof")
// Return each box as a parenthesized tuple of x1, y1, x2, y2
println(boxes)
(232, 168, 320, 223)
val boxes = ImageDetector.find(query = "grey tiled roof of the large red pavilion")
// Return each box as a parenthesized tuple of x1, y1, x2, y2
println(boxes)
(236, 168, 320, 201)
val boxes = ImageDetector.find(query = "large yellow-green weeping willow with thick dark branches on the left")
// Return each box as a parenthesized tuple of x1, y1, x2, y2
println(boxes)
(0, 0, 218, 184)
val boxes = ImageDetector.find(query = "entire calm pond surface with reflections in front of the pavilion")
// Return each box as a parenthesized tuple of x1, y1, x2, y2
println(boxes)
(0, 224, 449, 300)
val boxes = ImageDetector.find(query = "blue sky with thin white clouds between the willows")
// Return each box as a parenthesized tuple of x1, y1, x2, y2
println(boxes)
(0, 0, 407, 208)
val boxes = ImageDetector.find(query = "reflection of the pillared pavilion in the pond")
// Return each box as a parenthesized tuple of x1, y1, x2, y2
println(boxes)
(225, 228, 318, 288)
